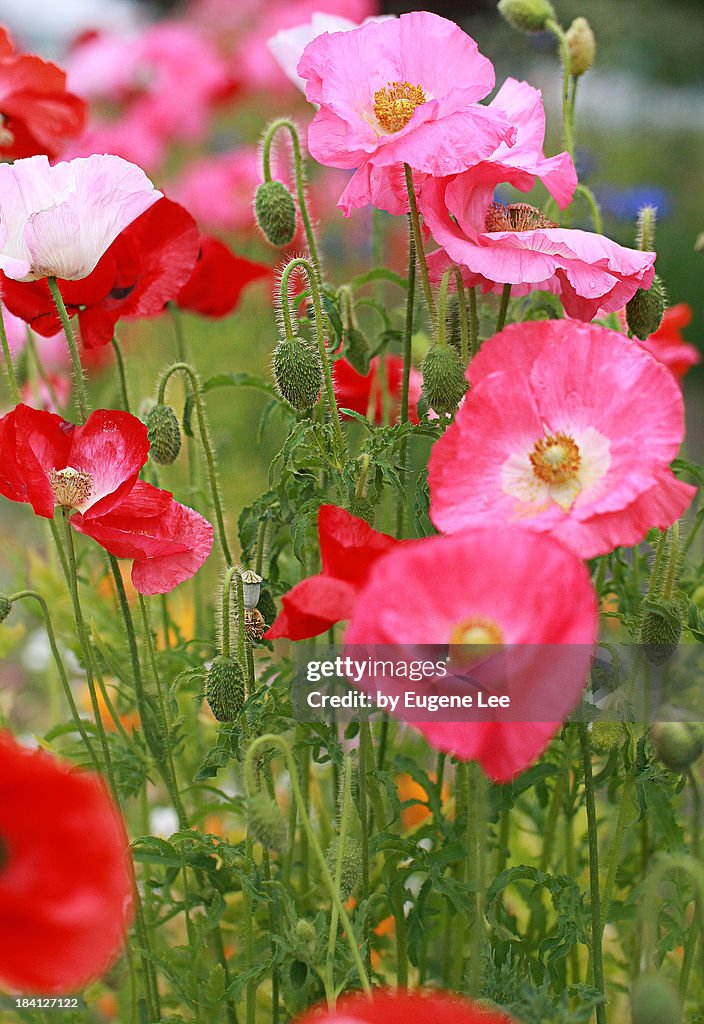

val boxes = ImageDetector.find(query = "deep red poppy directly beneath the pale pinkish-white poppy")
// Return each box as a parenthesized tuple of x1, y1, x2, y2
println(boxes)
(2, 199, 199, 348)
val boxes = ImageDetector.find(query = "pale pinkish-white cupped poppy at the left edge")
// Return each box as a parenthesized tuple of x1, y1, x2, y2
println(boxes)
(0, 155, 162, 281)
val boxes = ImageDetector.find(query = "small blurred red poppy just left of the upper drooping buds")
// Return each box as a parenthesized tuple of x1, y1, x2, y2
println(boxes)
(176, 236, 271, 318)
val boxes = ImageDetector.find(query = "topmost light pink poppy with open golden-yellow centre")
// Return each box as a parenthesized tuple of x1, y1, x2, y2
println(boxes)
(298, 11, 515, 198)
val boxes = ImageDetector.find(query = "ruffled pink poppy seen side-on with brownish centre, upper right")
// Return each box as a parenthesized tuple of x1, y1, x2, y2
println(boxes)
(421, 171, 655, 321)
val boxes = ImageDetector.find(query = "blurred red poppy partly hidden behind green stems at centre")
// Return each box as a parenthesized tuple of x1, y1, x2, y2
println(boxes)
(333, 355, 423, 424)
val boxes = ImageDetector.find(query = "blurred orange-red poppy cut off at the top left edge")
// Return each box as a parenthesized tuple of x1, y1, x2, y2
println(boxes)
(0, 27, 87, 160)
